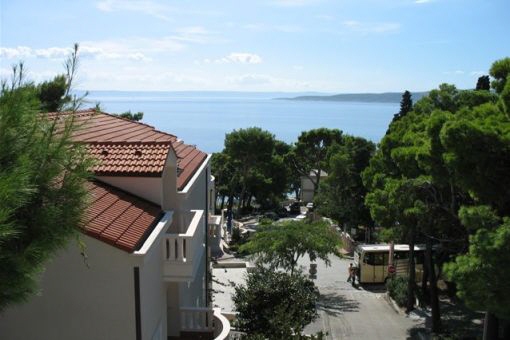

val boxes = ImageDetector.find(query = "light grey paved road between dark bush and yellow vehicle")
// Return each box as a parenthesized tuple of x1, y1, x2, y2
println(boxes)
(301, 257, 420, 340)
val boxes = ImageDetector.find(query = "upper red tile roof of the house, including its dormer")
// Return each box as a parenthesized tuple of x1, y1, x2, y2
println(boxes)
(48, 109, 207, 190)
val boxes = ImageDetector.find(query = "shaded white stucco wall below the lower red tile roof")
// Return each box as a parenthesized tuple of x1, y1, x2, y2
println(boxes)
(0, 235, 136, 340)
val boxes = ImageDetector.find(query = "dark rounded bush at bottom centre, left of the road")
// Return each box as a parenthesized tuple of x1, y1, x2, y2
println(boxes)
(232, 266, 319, 339)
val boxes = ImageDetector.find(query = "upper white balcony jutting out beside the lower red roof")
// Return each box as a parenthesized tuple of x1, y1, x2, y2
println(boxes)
(163, 210, 205, 282)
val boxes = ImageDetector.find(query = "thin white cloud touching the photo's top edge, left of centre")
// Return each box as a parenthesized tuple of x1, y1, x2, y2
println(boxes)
(96, 0, 173, 21)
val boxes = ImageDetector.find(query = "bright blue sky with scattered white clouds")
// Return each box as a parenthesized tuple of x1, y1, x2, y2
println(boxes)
(0, 0, 510, 93)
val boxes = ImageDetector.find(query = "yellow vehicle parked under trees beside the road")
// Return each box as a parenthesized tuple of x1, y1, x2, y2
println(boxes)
(354, 244, 425, 283)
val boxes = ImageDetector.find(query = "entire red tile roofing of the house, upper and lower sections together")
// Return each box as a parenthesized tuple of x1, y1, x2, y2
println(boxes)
(44, 110, 207, 252)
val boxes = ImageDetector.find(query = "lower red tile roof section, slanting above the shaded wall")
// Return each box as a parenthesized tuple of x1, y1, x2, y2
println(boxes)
(84, 181, 162, 252)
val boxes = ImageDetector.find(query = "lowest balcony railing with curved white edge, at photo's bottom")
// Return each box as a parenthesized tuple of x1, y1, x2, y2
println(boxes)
(180, 307, 230, 340)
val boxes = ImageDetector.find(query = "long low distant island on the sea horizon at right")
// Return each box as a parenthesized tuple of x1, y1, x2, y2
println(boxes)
(275, 92, 428, 103)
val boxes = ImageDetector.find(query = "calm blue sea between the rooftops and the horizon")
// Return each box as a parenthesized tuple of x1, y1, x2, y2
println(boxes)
(85, 91, 399, 153)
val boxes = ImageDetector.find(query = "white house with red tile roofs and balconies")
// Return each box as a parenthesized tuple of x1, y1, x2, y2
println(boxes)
(0, 110, 230, 340)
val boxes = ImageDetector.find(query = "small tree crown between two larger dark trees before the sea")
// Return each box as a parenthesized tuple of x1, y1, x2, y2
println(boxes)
(286, 128, 342, 192)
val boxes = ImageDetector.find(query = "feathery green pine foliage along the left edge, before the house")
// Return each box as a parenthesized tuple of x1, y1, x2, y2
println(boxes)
(0, 52, 91, 311)
